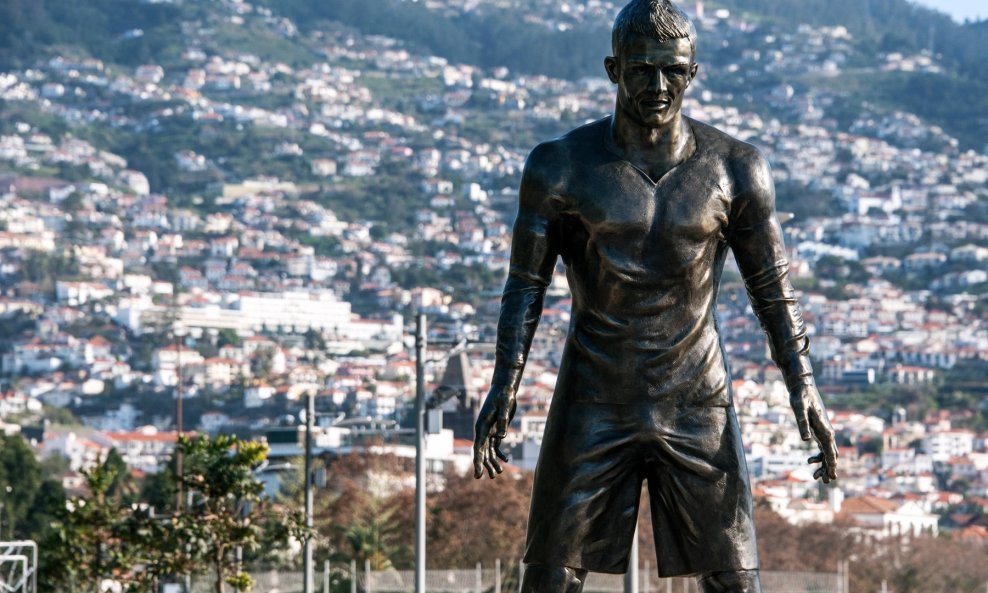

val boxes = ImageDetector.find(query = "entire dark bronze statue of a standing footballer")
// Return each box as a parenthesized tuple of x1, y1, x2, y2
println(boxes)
(474, 0, 837, 593)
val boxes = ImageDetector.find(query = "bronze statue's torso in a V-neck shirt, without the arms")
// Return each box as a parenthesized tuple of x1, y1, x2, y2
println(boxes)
(554, 120, 731, 405)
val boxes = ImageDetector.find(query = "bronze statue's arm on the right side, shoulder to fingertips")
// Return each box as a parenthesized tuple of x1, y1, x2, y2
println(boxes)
(728, 146, 837, 482)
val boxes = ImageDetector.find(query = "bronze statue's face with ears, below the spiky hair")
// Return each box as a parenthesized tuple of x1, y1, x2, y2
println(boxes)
(604, 34, 697, 128)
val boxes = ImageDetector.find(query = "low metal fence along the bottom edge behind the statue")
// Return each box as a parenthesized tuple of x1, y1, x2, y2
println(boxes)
(192, 565, 844, 593)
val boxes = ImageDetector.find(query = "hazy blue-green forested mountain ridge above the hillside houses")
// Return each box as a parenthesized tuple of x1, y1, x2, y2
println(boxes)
(0, 0, 988, 151)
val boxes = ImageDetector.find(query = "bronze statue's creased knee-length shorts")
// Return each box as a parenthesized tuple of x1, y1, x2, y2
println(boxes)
(525, 401, 758, 577)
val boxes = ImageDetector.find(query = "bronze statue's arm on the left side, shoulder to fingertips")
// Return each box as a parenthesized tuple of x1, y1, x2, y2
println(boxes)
(474, 144, 565, 478)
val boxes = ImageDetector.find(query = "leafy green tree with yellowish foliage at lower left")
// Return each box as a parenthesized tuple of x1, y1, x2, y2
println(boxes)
(40, 436, 303, 593)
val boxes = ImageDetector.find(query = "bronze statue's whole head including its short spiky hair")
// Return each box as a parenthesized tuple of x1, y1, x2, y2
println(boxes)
(604, 0, 697, 128)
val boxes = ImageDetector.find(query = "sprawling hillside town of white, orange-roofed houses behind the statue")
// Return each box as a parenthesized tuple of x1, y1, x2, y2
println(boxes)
(0, 0, 988, 543)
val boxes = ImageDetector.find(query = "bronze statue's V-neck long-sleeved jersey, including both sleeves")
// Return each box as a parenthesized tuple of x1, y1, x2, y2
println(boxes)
(495, 118, 812, 406)
